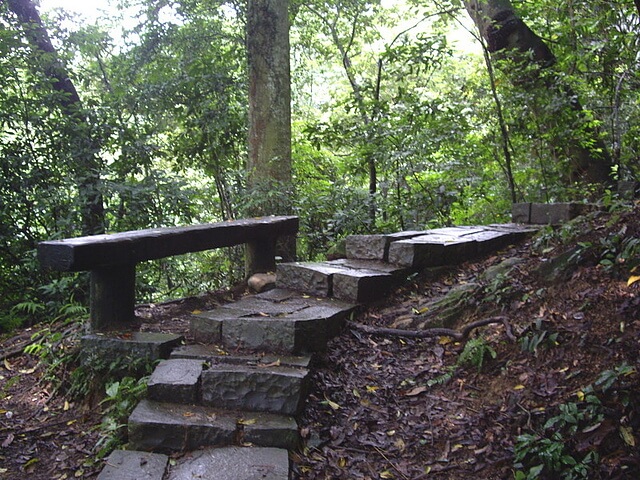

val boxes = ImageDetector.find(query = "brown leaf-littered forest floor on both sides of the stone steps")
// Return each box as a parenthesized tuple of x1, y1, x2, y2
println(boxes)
(0, 206, 640, 480)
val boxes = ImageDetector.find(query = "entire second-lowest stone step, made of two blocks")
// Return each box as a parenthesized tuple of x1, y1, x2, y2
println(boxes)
(128, 400, 300, 452)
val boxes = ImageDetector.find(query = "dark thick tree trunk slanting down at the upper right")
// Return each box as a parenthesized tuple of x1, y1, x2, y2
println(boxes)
(465, 0, 613, 185)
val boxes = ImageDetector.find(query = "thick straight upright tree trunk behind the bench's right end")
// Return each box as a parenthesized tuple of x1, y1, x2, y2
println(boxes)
(247, 0, 295, 261)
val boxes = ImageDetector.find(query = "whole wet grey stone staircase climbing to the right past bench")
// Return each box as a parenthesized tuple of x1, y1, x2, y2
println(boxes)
(98, 224, 536, 480)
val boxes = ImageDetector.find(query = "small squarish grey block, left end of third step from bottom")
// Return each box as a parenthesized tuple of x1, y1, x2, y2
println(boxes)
(147, 359, 202, 403)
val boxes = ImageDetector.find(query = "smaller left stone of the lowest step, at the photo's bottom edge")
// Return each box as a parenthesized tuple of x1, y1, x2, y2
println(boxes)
(97, 450, 169, 480)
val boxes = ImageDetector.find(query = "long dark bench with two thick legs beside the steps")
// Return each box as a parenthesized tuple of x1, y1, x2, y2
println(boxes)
(38, 217, 299, 331)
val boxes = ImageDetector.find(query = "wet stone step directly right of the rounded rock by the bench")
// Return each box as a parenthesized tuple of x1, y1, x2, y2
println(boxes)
(276, 259, 407, 303)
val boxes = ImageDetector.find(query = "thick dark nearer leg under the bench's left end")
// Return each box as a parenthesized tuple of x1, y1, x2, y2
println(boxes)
(90, 265, 136, 332)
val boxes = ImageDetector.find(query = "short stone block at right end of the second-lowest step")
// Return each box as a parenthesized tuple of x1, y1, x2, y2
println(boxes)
(238, 412, 300, 450)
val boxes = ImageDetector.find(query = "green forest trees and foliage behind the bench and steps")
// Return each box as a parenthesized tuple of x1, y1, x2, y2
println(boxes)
(0, 0, 640, 332)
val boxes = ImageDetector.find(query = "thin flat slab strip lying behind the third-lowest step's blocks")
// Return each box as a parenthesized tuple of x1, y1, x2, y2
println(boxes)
(171, 344, 311, 368)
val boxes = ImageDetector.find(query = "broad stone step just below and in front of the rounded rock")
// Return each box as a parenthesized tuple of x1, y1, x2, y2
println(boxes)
(190, 289, 356, 355)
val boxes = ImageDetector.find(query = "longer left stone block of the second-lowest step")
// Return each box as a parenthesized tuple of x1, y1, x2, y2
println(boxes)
(128, 400, 236, 452)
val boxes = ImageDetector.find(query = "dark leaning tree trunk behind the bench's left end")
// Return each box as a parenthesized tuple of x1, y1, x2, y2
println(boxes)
(7, 0, 105, 235)
